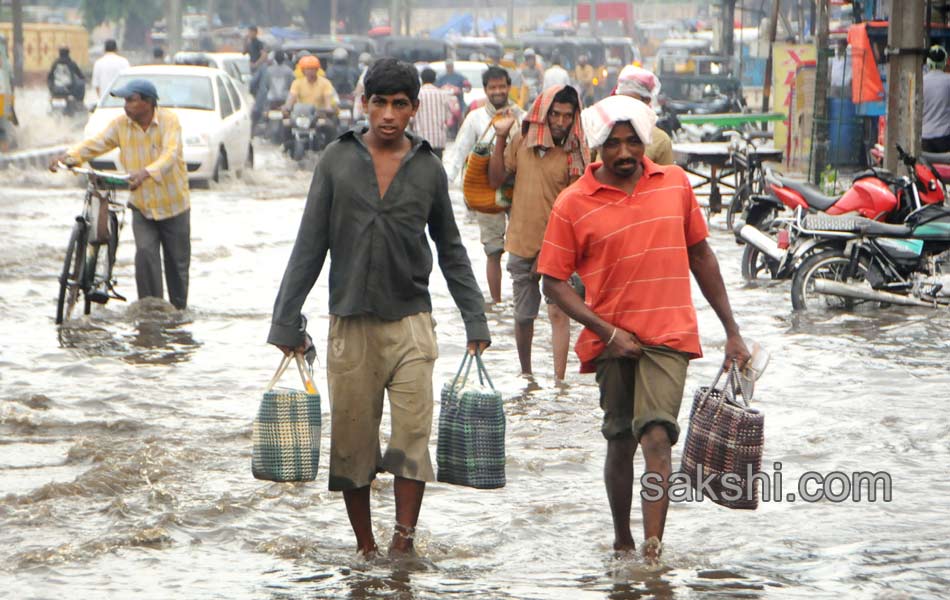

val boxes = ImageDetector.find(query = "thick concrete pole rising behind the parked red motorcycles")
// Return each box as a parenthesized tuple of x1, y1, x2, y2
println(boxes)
(884, 0, 927, 172)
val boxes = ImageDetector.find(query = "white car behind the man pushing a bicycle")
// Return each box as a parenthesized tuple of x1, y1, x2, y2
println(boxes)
(85, 65, 254, 182)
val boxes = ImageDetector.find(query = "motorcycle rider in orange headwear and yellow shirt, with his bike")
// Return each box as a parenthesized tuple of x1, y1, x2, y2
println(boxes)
(283, 56, 337, 161)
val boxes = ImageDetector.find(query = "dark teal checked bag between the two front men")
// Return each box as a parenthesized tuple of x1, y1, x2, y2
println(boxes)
(436, 353, 505, 490)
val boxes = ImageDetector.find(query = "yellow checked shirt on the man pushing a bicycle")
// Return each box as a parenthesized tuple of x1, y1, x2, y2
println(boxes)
(66, 108, 191, 221)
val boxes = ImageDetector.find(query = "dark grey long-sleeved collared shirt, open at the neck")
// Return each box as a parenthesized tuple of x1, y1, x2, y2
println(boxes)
(267, 129, 491, 347)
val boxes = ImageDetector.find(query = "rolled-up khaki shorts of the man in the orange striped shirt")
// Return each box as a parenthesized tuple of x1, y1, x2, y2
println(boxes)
(596, 346, 689, 444)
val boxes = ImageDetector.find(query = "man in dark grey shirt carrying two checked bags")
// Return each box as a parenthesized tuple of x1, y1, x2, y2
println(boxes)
(267, 58, 490, 557)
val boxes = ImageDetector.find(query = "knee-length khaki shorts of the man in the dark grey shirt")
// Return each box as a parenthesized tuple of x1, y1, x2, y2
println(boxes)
(327, 312, 439, 491)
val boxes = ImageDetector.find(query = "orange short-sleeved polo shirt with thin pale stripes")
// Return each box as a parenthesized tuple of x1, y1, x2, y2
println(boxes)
(538, 158, 709, 373)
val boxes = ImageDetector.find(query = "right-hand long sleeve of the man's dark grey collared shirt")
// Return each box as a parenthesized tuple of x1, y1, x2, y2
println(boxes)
(429, 170, 491, 347)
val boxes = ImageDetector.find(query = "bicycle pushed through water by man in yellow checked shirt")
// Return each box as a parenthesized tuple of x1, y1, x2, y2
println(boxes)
(56, 163, 129, 325)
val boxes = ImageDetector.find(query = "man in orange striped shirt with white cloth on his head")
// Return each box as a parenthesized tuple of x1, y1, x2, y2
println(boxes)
(538, 96, 749, 564)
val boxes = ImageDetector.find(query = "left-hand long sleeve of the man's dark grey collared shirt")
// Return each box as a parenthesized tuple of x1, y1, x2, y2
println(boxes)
(267, 161, 333, 349)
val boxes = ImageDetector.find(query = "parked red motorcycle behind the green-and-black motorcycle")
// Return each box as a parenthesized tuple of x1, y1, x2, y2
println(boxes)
(734, 148, 946, 281)
